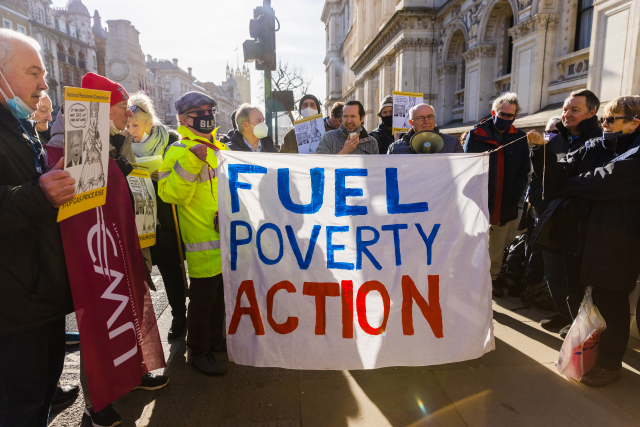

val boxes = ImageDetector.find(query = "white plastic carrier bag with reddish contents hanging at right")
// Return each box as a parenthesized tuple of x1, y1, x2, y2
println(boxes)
(557, 286, 607, 381)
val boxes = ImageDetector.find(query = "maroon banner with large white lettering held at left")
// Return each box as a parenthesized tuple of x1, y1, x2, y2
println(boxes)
(60, 159, 166, 411)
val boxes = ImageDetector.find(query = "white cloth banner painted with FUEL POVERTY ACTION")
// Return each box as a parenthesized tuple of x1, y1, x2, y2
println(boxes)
(218, 151, 494, 369)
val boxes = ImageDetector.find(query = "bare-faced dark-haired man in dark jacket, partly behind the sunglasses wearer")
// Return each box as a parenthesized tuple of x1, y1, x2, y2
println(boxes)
(529, 89, 602, 338)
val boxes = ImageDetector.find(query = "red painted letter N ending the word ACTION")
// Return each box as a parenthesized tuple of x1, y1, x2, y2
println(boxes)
(402, 275, 444, 338)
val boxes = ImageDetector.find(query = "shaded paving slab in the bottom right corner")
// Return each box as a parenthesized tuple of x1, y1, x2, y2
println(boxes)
(434, 365, 639, 427)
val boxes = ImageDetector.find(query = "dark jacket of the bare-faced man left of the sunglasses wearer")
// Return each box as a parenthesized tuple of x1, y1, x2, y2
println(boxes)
(528, 116, 602, 215)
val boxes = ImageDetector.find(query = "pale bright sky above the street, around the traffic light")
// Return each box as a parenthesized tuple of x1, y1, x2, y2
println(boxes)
(67, 0, 326, 106)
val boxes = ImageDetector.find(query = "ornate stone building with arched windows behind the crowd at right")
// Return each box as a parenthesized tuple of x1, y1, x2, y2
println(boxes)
(321, 0, 640, 133)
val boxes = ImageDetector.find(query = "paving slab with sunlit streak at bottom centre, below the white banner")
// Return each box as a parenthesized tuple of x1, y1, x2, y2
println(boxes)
(300, 370, 466, 427)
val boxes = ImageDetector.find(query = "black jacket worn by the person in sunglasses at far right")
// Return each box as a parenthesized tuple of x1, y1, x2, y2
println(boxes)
(531, 132, 640, 292)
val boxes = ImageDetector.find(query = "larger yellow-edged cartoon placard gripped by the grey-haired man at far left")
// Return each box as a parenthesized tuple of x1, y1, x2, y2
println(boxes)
(58, 87, 111, 221)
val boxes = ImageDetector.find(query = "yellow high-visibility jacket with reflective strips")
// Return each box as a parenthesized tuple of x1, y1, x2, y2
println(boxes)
(158, 126, 227, 278)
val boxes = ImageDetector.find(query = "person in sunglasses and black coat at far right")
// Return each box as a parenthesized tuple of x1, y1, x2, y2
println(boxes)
(529, 96, 640, 386)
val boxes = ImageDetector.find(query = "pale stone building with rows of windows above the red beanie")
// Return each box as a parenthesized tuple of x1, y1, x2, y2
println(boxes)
(22, 0, 98, 106)
